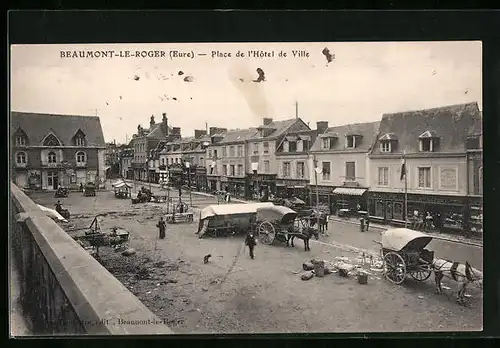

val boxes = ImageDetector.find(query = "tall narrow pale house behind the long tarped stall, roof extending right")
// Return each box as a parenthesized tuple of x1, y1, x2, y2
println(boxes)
(246, 117, 310, 200)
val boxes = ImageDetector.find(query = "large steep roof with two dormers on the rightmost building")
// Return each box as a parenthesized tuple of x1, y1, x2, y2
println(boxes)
(372, 103, 482, 154)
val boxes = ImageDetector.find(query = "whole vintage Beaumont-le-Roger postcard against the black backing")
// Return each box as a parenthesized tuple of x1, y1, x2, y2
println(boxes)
(9, 41, 483, 336)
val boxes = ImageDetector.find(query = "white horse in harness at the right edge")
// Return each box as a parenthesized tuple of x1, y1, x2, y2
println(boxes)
(432, 259, 483, 304)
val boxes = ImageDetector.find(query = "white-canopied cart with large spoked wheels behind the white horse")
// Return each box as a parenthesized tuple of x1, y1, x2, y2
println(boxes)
(376, 228, 434, 284)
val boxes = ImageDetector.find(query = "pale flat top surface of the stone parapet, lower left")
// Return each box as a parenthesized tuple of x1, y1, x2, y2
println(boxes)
(11, 183, 174, 335)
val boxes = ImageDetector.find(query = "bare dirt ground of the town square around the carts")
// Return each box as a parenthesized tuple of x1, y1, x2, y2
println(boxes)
(31, 191, 482, 333)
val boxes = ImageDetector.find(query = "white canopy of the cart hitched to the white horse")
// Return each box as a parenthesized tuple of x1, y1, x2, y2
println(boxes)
(382, 228, 432, 251)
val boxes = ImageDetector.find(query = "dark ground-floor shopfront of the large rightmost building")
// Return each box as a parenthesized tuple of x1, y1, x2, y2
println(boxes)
(368, 192, 470, 231)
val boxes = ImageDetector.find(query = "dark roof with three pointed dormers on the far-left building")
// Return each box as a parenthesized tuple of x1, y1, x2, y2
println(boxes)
(10, 111, 106, 147)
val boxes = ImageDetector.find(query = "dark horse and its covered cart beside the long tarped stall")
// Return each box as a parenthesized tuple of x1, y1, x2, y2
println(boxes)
(257, 205, 318, 250)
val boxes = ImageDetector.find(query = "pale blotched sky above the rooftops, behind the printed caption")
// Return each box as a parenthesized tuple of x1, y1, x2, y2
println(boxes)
(10, 41, 482, 143)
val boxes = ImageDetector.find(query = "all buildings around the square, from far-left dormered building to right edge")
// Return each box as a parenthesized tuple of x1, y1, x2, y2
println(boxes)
(11, 103, 483, 234)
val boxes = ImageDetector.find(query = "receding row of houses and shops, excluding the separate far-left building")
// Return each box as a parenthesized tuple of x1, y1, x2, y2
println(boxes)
(121, 103, 483, 231)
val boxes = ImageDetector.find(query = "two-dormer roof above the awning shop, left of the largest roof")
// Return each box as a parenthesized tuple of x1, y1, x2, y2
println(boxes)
(311, 121, 380, 152)
